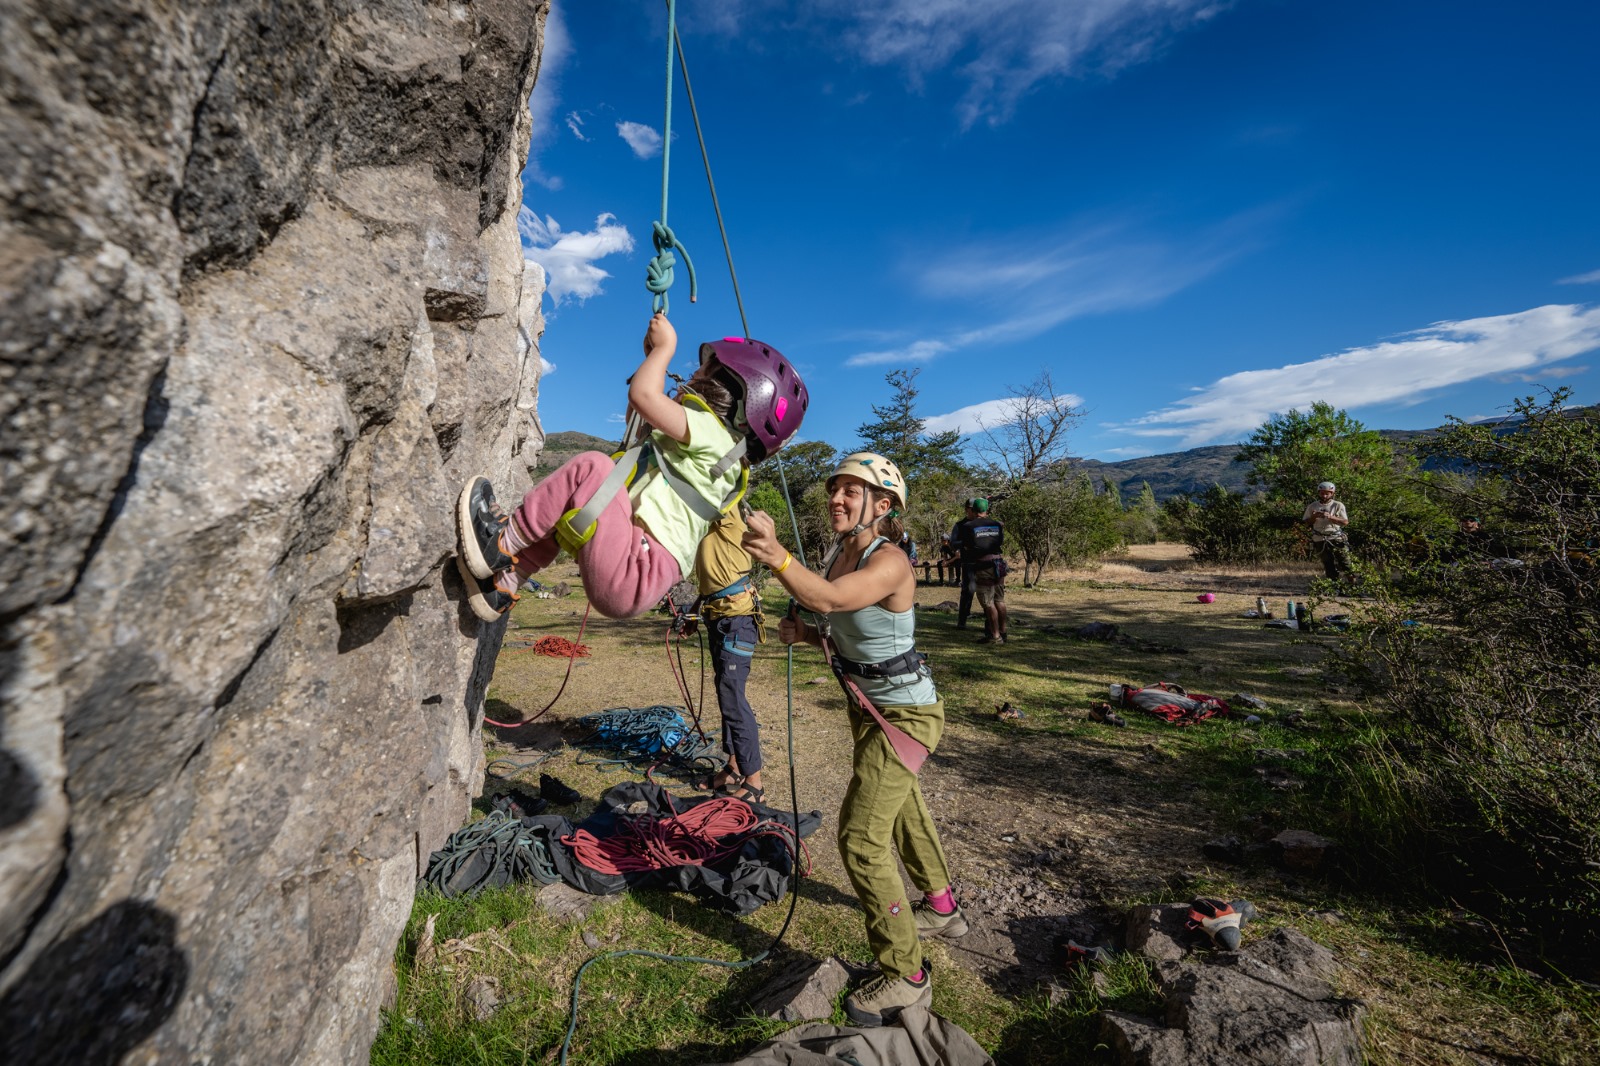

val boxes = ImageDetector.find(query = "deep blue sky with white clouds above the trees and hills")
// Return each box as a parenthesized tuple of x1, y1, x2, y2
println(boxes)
(522, 0, 1600, 459)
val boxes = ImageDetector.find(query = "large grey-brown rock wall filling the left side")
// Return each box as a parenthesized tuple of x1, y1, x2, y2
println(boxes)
(0, 0, 547, 1063)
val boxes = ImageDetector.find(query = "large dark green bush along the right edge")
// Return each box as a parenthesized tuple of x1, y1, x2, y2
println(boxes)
(1344, 391, 1600, 952)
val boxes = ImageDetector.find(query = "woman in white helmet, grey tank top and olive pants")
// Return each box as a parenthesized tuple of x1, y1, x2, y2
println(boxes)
(744, 451, 968, 1026)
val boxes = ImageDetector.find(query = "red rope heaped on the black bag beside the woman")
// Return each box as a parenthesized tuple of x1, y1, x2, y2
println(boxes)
(562, 797, 810, 874)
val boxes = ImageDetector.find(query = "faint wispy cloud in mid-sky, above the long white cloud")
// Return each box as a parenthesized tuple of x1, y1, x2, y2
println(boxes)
(845, 205, 1283, 367)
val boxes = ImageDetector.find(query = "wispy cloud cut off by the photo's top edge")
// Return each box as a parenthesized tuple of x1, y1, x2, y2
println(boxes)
(826, 0, 1229, 128)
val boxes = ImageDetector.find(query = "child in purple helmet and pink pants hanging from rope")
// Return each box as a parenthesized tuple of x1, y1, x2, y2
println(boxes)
(456, 312, 810, 621)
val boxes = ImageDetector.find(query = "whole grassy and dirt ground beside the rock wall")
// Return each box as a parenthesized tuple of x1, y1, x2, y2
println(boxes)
(373, 544, 1600, 1066)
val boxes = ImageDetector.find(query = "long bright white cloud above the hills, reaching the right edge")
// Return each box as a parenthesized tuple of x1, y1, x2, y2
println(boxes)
(1114, 304, 1600, 448)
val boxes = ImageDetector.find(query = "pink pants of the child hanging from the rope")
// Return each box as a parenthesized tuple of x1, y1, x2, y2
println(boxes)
(510, 451, 682, 618)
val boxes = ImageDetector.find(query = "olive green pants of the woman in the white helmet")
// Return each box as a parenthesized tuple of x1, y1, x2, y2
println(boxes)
(838, 701, 950, 976)
